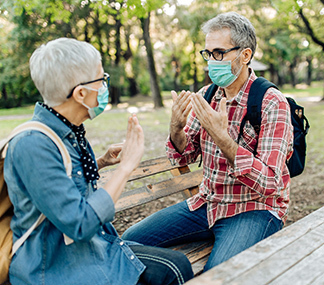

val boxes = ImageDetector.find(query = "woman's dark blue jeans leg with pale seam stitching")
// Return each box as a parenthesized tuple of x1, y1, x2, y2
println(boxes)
(129, 245, 193, 285)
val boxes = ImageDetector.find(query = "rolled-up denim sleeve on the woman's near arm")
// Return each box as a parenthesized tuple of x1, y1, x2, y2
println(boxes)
(6, 132, 115, 241)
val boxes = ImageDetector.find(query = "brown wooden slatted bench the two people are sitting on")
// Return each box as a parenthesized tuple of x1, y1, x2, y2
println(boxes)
(100, 156, 212, 275)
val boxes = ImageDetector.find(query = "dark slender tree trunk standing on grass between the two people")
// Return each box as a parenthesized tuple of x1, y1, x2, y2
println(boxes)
(141, 13, 163, 108)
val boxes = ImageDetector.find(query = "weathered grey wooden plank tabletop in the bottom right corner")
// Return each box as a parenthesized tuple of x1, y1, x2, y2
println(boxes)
(186, 203, 324, 285)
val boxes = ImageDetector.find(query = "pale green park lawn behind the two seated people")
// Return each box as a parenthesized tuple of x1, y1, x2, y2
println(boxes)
(0, 82, 324, 163)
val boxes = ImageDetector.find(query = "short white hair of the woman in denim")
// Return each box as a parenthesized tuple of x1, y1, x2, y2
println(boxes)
(29, 38, 101, 107)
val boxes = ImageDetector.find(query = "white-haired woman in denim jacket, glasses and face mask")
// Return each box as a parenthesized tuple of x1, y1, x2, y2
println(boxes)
(4, 38, 192, 285)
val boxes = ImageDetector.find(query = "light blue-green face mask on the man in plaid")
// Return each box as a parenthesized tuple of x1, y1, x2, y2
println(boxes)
(208, 53, 243, 88)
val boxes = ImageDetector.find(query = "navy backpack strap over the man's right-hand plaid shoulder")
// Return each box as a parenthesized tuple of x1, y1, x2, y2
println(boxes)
(237, 77, 278, 155)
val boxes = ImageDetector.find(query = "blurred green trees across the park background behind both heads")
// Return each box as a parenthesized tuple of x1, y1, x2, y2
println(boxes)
(0, 0, 324, 108)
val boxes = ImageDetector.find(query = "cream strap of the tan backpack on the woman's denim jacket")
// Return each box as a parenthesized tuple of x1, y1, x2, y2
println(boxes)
(5, 121, 72, 257)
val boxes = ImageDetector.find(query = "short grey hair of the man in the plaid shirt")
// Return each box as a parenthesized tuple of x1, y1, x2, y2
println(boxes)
(202, 12, 257, 64)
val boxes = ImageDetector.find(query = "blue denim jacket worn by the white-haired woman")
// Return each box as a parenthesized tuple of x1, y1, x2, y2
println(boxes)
(4, 104, 145, 285)
